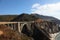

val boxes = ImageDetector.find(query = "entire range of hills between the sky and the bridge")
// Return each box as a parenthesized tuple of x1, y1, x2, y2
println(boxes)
(0, 13, 60, 24)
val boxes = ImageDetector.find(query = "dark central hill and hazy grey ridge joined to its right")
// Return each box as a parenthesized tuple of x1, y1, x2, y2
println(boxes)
(11, 14, 60, 24)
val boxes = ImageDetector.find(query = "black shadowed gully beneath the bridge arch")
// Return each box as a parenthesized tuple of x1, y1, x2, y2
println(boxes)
(22, 25, 50, 40)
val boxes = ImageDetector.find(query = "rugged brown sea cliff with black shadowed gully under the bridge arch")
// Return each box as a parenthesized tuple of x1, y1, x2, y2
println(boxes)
(22, 19, 59, 40)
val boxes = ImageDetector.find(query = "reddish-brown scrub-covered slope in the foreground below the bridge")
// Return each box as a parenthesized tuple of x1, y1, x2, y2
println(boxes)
(0, 25, 32, 40)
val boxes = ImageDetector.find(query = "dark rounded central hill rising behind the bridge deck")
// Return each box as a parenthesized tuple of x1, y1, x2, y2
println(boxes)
(11, 13, 38, 21)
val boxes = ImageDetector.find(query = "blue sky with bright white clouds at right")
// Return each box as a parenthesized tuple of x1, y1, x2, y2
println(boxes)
(0, 0, 60, 19)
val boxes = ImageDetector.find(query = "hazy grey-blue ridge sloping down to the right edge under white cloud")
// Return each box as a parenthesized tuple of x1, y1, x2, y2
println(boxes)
(32, 14, 60, 24)
